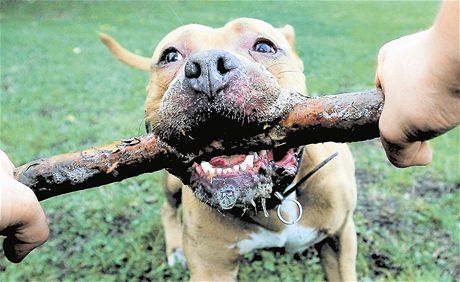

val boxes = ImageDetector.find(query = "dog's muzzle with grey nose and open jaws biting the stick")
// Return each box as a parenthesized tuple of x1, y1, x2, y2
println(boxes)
(151, 49, 308, 212)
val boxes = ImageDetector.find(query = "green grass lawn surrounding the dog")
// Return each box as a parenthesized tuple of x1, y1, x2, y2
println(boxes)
(0, 1, 460, 281)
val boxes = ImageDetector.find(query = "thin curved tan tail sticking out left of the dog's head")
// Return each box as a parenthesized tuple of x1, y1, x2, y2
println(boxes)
(99, 33, 150, 71)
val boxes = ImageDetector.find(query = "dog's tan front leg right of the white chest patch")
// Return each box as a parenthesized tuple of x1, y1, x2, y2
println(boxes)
(316, 215, 357, 281)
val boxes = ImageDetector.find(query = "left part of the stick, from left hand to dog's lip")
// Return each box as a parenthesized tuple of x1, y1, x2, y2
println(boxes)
(14, 135, 178, 200)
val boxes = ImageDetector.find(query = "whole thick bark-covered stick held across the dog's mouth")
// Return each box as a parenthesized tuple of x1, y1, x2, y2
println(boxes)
(14, 89, 383, 200)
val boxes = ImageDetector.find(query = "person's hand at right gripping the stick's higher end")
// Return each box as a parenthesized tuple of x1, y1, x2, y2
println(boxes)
(376, 11, 460, 167)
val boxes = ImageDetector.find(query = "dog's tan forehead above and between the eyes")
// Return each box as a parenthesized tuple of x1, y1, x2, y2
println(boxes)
(153, 19, 290, 59)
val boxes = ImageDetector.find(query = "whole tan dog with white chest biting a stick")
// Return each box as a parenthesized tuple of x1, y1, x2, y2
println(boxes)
(101, 18, 357, 281)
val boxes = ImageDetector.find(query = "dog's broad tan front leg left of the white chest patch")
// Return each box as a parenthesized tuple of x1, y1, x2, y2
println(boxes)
(182, 187, 241, 281)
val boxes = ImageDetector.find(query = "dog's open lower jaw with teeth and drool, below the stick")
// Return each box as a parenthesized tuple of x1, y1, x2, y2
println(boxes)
(190, 149, 300, 211)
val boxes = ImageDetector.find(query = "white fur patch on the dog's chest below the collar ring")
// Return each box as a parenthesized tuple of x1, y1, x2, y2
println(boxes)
(236, 194, 326, 254)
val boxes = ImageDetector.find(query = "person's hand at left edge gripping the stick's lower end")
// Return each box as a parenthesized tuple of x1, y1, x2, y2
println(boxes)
(0, 150, 49, 263)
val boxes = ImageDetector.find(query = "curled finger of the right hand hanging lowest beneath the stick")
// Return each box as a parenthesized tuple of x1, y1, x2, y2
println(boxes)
(381, 138, 433, 168)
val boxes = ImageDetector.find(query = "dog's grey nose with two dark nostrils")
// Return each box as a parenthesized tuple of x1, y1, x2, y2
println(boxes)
(184, 50, 240, 95)
